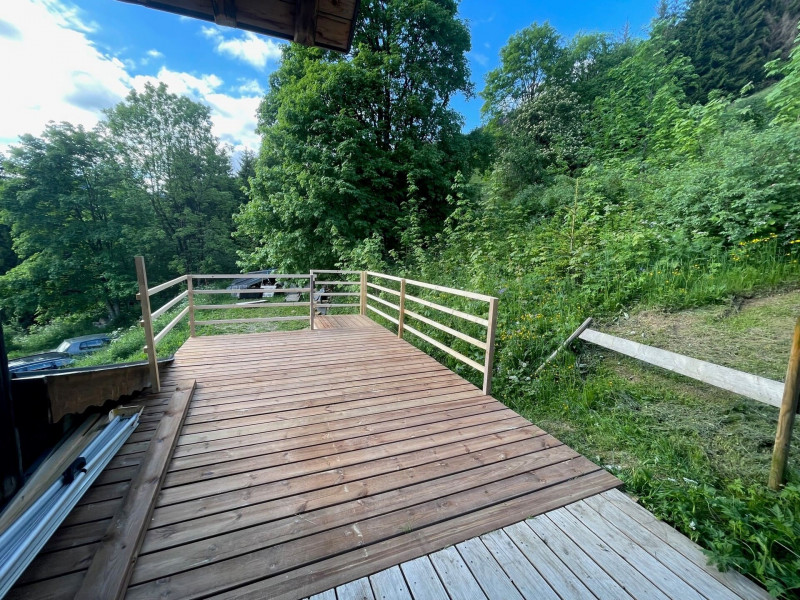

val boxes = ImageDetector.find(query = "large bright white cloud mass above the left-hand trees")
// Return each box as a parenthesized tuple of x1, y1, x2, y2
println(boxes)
(0, 0, 263, 151)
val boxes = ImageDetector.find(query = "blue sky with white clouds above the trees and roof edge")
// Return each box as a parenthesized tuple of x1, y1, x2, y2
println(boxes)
(0, 0, 655, 157)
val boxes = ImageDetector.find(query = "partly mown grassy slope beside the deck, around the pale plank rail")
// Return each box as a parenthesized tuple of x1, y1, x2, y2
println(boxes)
(505, 289, 800, 597)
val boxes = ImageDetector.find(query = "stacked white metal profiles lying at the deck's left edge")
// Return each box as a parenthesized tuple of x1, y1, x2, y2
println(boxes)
(0, 413, 140, 598)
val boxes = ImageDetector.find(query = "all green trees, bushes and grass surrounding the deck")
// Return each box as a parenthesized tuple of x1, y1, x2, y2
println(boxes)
(0, 0, 800, 597)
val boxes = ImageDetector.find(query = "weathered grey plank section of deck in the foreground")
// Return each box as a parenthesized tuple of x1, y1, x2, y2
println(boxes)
(311, 490, 770, 600)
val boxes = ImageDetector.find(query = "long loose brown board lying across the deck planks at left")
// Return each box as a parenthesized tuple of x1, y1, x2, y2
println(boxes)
(75, 381, 195, 600)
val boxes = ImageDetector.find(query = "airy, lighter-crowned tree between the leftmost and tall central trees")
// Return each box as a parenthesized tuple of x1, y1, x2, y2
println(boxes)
(105, 83, 236, 273)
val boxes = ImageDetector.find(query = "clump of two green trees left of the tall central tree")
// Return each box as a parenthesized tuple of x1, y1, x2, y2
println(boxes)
(0, 84, 243, 324)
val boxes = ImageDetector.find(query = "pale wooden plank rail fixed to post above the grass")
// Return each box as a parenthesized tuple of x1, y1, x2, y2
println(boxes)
(578, 329, 784, 407)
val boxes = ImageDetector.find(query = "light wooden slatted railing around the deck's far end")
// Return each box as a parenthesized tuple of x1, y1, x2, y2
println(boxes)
(136, 256, 498, 394)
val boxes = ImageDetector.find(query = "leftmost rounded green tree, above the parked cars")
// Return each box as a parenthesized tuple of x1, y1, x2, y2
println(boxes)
(0, 123, 141, 320)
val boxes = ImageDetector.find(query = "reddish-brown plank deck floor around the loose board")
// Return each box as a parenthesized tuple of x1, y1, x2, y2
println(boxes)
(8, 317, 768, 599)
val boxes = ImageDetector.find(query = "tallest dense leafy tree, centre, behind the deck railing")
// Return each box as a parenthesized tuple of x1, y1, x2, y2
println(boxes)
(237, 0, 471, 269)
